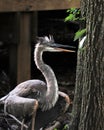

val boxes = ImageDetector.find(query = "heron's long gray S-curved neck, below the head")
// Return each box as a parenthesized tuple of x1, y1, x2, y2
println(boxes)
(34, 44, 58, 105)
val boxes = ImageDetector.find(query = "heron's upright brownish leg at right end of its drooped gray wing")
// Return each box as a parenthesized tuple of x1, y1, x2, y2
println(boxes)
(31, 100, 38, 130)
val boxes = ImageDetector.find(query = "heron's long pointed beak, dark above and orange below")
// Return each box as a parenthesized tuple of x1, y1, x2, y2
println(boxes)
(52, 43, 75, 52)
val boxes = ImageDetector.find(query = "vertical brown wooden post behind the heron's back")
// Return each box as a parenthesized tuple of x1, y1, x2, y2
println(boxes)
(17, 13, 31, 83)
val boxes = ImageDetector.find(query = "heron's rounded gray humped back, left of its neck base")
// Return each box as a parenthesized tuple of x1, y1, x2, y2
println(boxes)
(10, 80, 47, 98)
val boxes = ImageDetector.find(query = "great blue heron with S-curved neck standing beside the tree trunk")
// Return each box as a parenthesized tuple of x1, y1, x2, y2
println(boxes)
(0, 37, 74, 130)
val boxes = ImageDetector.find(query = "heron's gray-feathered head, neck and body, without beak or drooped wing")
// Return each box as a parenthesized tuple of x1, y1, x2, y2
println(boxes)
(1, 37, 58, 111)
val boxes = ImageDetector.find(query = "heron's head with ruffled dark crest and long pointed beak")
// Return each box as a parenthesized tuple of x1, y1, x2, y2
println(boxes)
(36, 36, 75, 52)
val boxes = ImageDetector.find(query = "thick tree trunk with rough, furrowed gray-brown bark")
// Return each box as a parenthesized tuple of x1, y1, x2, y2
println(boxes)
(69, 0, 104, 130)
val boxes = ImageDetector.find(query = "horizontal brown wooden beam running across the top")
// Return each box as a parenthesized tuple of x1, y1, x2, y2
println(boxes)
(0, 0, 80, 12)
